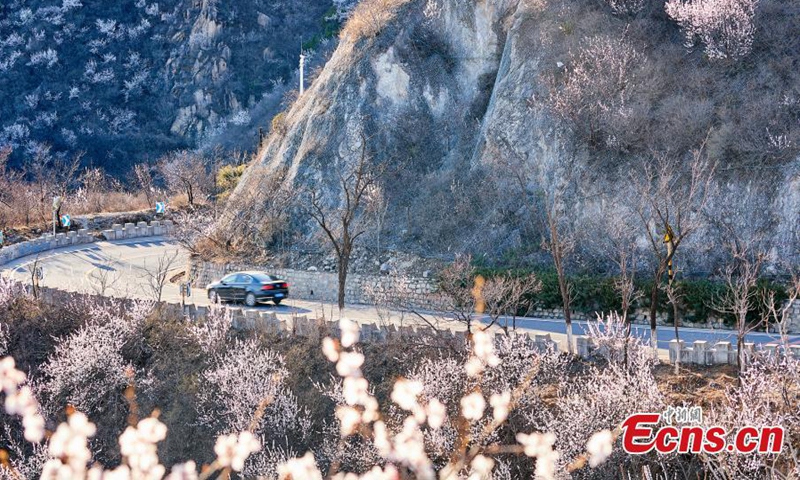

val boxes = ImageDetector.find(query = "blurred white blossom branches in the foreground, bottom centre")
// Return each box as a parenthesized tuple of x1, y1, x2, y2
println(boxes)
(278, 319, 615, 480)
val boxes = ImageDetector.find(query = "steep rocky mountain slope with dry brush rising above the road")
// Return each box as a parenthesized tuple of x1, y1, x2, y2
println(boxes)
(225, 0, 800, 272)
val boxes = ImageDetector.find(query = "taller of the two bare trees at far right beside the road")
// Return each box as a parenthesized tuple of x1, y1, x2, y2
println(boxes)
(713, 244, 765, 372)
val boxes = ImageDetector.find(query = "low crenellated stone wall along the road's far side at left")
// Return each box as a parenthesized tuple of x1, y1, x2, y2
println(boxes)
(0, 220, 173, 265)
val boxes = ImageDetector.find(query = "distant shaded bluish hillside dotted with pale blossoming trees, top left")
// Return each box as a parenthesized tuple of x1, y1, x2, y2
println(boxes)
(0, 0, 336, 175)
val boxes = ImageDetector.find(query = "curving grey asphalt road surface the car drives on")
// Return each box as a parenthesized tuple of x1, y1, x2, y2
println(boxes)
(0, 237, 800, 354)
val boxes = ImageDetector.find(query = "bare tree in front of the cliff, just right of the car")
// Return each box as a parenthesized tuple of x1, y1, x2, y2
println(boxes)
(304, 133, 384, 310)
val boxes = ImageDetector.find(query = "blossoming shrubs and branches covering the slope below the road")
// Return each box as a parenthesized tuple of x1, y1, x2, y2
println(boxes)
(0, 279, 800, 480)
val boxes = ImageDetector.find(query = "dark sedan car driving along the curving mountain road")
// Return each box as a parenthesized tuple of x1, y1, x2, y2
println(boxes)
(206, 272, 289, 307)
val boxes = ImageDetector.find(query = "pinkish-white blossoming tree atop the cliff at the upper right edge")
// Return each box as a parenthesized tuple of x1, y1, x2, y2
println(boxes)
(664, 0, 758, 60)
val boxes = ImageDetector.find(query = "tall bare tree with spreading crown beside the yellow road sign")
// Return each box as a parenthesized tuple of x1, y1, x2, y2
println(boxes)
(631, 143, 715, 352)
